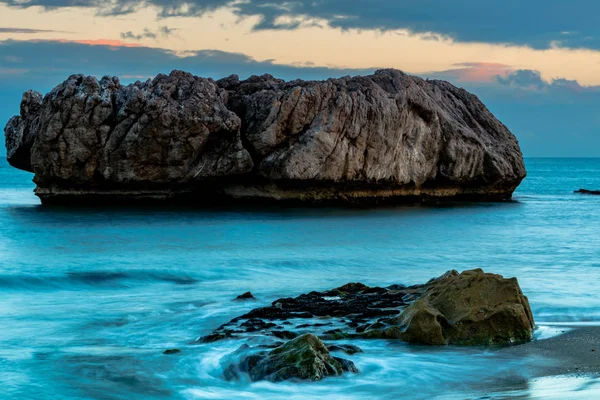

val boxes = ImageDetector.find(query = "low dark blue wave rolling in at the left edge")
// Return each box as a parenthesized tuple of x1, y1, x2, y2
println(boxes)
(0, 270, 198, 290)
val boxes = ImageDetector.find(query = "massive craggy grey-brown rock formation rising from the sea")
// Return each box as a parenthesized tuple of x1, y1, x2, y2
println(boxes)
(5, 70, 525, 203)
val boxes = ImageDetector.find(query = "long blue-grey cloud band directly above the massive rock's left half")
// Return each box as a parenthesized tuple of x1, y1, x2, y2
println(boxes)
(0, 40, 366, 83)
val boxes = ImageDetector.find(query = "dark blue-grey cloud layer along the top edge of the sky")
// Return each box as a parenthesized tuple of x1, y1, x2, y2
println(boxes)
(0, 0, 600, 49)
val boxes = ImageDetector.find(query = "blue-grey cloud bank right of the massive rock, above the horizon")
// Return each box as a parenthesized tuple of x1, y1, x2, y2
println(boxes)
(448, 70, 600, 157)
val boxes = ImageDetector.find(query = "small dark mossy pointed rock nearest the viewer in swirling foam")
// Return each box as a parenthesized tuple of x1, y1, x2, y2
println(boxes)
(233, 334, 358, 382)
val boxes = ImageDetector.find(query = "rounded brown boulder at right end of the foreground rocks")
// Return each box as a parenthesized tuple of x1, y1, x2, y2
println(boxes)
(376, 269, 535, 345)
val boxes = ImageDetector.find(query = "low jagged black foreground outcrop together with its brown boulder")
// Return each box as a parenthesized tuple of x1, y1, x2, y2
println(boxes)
(200, 269, 535, 345)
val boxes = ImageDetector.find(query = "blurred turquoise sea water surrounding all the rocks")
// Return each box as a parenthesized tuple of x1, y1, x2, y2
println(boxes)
(0, 159, 600, 399)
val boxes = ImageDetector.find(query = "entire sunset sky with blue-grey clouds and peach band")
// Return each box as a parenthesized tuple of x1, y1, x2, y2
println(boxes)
(0, 0, 600, 157)
